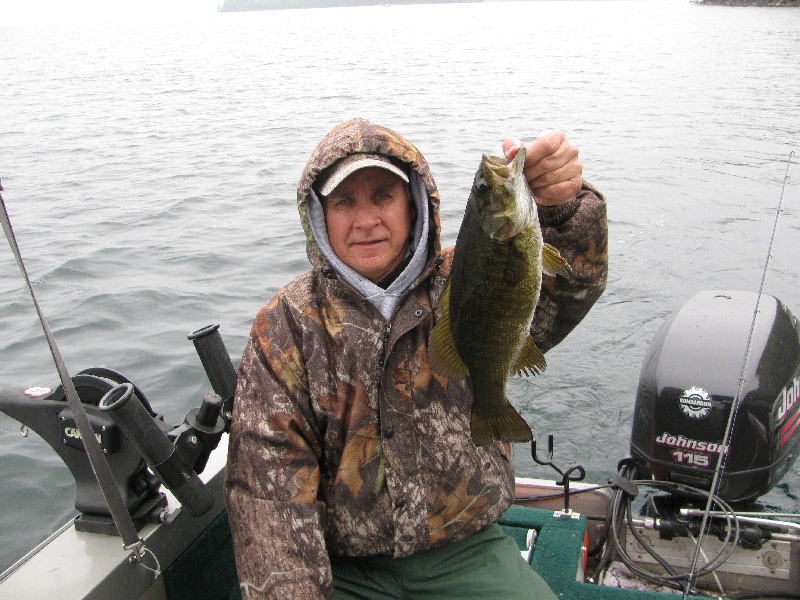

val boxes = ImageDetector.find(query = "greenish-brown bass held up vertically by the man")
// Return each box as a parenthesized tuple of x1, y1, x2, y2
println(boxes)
(431, 148, 569, 445)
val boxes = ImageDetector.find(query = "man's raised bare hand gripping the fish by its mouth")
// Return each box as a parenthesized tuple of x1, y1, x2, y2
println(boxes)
(503, 131, 583, 206)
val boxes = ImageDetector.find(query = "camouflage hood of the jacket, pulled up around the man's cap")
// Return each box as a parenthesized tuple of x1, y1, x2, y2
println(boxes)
(297, 119, 441, 276)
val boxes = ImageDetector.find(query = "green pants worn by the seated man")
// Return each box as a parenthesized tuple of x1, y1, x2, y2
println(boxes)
(331, 523, 556, 600)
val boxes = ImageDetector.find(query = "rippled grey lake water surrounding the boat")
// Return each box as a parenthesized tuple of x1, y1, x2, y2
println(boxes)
(0, 0, 800, 571)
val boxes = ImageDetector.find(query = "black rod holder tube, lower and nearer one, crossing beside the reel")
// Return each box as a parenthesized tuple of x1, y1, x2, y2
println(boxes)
(99, 383, 214, 517)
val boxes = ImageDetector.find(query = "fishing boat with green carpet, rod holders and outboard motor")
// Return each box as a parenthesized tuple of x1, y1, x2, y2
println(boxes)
(0, 290, 800, 600)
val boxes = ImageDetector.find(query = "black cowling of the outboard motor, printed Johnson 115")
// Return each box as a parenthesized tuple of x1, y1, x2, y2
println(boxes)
(631, 291, 800, 502)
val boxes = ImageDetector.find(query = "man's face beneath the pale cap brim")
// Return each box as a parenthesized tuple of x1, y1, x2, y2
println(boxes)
(323, 167, 413, 283)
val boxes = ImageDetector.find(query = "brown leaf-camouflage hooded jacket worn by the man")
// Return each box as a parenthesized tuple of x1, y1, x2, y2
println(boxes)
(225, 120, 607, 599)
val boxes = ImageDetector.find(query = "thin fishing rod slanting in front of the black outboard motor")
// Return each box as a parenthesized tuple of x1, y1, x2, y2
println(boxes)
(682, 150, 794, 600)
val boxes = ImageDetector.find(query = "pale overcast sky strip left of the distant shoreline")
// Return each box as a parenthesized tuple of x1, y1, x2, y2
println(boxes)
(0, 0, 222, 27)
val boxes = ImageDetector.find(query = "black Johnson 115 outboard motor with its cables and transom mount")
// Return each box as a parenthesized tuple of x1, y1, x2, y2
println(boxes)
(580, 291, 800, 598)
